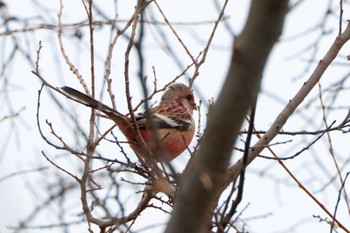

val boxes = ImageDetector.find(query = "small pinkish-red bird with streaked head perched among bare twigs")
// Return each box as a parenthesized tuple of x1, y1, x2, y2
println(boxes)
(61, 83, 197, 161)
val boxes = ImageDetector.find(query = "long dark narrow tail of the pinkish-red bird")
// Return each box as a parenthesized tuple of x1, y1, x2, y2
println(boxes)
(61, 86, 127, 121)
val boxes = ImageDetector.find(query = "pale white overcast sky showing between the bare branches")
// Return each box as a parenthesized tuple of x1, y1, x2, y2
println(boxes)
(0, 0, 350, 233)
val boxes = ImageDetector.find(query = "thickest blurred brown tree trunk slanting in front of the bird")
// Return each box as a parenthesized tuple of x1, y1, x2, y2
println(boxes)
(166, 0, 288, 233)
